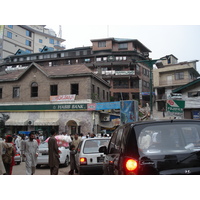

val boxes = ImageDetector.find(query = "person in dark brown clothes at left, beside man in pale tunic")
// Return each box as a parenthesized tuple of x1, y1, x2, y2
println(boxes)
(2, 135, 16, 175)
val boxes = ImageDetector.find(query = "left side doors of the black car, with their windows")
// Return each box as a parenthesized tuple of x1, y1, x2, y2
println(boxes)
(105, 127, 123, 175)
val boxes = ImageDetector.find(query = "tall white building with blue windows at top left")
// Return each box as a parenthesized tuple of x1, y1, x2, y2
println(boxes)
(0, 25, 65, 60)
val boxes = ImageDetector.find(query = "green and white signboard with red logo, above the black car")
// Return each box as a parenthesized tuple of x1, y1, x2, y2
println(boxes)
(167, 99, 185, 118)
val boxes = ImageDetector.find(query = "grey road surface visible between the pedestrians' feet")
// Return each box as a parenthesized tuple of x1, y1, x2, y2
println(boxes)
(12, 162, 70, 175)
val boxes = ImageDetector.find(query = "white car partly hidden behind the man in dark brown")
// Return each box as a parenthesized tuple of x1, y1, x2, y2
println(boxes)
(36, 142, 70, 168)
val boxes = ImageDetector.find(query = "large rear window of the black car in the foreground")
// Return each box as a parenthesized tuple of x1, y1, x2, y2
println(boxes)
(137, 124, 200, 155)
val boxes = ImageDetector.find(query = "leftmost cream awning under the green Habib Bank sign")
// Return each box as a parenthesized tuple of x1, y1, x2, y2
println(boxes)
(5, 113, 29, 126)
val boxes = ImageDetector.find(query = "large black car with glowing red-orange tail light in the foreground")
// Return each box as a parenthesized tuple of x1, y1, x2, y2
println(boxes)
(99, 119, 200, 175)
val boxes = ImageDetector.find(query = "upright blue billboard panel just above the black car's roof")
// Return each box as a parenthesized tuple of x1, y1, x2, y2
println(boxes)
(120, 100, 138, 124)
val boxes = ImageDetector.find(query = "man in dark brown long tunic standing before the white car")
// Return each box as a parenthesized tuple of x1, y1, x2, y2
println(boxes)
(48, 129, 60, 175)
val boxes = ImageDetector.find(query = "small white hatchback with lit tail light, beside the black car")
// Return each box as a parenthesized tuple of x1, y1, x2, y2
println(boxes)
(75, 137, 110, 175)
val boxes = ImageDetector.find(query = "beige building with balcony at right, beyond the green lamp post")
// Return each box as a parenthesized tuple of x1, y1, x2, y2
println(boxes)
(153, 55, 200, 111)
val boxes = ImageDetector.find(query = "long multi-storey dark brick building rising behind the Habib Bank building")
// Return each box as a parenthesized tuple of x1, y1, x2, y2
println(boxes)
(1, 38, 151, 106)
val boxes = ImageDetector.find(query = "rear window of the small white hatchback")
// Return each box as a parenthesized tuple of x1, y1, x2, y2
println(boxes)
(83, 139, 109, 153)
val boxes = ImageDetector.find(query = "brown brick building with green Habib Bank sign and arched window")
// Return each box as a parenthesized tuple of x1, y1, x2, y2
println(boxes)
(0, 62, 110, 136)
